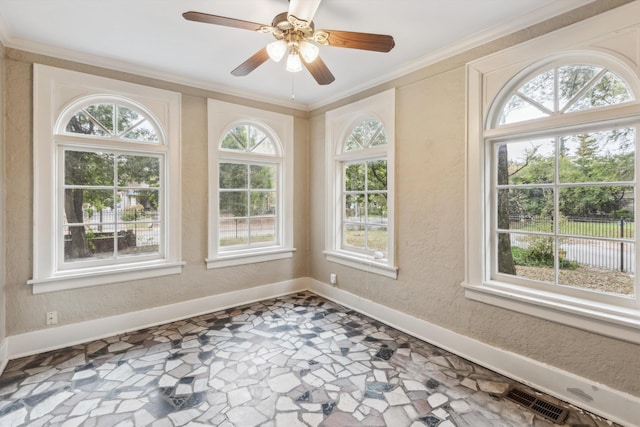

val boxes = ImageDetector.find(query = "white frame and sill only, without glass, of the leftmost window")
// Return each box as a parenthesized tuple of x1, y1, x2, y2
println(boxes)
(27, 64, 184, 294)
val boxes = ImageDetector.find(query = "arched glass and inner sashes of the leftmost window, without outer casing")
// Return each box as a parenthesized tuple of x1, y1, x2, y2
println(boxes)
(54, 97, 165, 270)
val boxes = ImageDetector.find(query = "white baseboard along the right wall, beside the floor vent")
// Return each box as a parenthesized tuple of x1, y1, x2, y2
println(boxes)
(307, 278, 640, 426)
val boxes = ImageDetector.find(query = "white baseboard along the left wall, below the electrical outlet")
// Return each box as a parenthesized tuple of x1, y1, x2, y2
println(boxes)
(7, 278, 308, 360)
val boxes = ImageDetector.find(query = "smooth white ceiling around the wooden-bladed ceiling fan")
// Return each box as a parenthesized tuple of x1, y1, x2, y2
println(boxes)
(0, 0, 593, 109)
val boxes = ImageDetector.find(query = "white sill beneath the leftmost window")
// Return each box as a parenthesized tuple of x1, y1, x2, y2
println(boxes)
(27, 262, 185, 294)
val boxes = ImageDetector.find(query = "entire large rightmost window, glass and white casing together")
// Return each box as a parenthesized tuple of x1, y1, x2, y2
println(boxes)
(465, 6, 640, 342)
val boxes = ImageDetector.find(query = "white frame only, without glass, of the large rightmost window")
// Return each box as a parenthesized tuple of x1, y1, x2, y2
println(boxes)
(462, 2, 640, 343)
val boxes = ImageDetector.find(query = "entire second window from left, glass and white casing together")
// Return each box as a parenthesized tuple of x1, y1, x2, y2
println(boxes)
(207, 100, 294, 268)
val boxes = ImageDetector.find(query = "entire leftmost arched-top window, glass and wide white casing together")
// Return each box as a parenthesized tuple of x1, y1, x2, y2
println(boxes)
(31, 66, 181, 292)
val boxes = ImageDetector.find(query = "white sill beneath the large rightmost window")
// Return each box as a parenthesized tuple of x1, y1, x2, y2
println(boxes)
(462, 282, 640, 344)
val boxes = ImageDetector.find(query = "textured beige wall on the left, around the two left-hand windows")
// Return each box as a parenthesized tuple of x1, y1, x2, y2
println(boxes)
(6, 49, 308, 335)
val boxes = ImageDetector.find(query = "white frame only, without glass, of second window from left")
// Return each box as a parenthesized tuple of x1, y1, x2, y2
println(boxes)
(205, 99, 296, 269)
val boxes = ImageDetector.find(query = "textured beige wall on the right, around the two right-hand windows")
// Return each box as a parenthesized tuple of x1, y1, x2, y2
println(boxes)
(310, 2, 640, 396)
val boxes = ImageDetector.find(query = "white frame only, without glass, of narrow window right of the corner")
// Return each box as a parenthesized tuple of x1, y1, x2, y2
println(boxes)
(324, 89, 399, 279)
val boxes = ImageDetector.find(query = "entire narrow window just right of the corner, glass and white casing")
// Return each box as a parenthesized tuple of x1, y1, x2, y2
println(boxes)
(325, 90, 398, 278)
